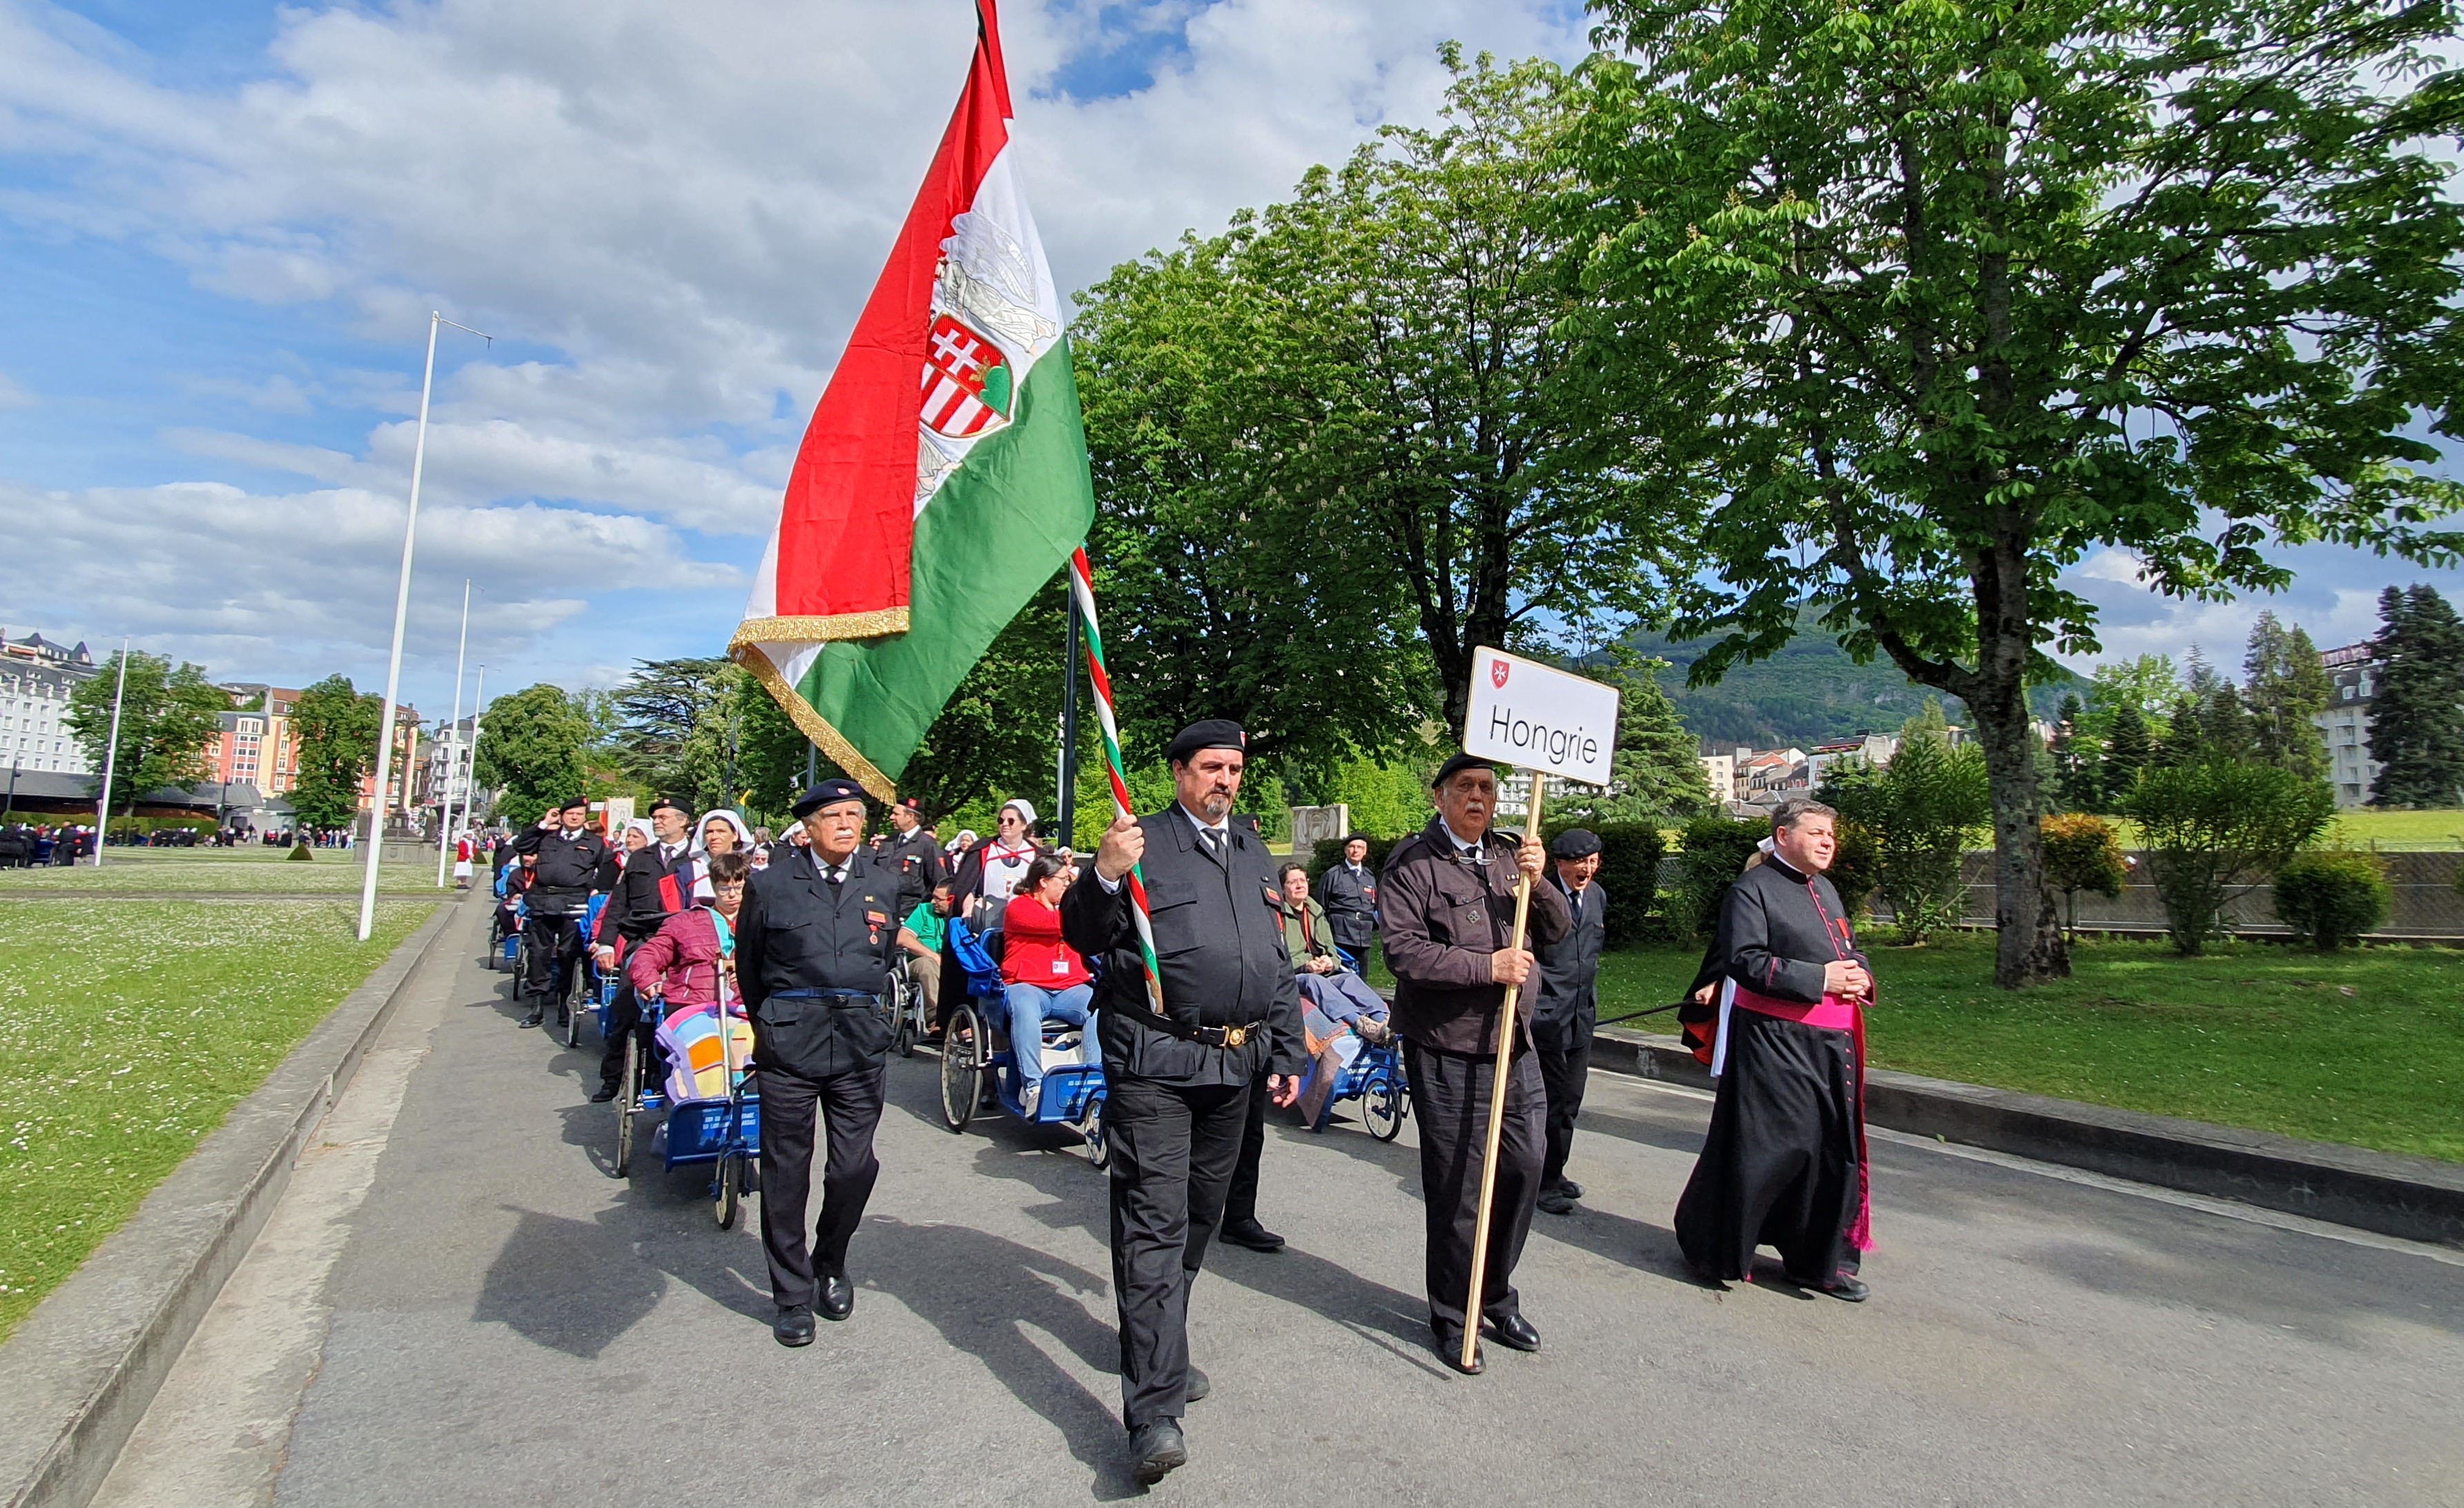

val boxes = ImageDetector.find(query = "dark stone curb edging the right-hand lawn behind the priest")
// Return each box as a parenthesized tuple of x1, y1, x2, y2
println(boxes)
(1592, 1027, 2464, 1247)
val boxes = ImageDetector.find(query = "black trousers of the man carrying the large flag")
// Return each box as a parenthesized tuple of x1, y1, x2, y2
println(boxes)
(1103, 1074, 1249, 1429)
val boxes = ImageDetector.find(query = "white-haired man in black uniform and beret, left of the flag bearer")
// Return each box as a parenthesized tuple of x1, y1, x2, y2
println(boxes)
(737, 781, 900, 1345)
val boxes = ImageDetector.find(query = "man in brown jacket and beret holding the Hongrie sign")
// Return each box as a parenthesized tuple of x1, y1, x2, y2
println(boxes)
(1377, 754, 1569, 1373)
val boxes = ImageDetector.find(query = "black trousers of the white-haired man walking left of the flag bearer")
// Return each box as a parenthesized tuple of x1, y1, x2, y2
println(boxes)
(754, 1062, 889, 1308)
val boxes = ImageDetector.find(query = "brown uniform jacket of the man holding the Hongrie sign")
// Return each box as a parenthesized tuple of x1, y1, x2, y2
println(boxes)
(1377, 818, 1572, 1054)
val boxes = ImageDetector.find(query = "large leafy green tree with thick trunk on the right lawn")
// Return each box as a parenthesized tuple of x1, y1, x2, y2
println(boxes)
(1575, 0, 2464, 988)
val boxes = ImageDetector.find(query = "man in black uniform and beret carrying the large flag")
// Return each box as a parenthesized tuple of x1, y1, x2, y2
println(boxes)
(1062, 719, 1303, 1483)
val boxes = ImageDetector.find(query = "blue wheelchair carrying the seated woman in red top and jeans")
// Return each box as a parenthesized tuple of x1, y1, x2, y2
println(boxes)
(941, 917, 1112, 1168)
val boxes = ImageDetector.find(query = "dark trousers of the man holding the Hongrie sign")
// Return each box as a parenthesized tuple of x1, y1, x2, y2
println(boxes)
(1402, 1040, 1547, 1348)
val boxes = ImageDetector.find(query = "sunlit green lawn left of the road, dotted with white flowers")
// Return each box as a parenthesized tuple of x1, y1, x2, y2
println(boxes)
(0, 896, 434, 1338)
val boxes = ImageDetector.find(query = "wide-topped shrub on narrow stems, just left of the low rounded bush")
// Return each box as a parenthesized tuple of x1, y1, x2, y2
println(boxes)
(2124, 759, 2336, 954)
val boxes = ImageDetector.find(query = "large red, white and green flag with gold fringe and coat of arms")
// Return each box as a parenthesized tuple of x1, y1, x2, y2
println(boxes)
(727, 0, 1094, 801)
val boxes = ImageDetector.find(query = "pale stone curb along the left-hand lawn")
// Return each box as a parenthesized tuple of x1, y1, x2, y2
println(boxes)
(0, 892, 476, 1508)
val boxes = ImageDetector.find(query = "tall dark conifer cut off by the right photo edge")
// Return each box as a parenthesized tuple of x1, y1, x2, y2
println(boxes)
(2370, 584, 2464, 806)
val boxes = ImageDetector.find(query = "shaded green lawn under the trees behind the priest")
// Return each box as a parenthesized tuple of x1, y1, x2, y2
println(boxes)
(1599, 934, 2464, 1161)
